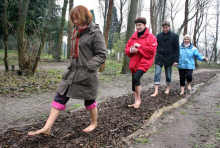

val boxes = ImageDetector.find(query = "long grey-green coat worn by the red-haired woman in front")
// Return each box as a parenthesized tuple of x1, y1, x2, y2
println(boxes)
(57, 23, 107, 100)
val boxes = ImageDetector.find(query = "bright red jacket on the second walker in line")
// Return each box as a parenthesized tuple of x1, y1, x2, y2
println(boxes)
(125, 28, 157, 73)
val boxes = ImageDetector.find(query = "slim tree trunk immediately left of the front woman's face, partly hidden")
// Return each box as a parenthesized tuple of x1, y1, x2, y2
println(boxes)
(67, 0, 74, 58)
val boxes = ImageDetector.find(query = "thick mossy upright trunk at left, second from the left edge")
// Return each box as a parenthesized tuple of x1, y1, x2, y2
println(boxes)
(17, 0, 31, 74)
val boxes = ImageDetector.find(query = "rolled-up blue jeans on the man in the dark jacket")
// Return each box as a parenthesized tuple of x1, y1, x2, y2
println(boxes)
(154, 64, 172, 85)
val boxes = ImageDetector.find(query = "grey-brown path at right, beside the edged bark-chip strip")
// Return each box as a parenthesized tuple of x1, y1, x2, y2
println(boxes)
(130, 73, 220, 148)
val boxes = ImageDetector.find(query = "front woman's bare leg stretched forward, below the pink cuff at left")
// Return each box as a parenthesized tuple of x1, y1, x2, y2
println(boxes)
(28, 107, 60, 136)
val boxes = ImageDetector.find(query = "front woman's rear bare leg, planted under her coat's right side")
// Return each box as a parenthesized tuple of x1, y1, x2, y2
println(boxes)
(83, 107, 98, 133)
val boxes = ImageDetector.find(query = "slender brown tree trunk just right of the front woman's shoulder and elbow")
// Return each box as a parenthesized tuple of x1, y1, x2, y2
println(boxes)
(99, 0, 114, 72)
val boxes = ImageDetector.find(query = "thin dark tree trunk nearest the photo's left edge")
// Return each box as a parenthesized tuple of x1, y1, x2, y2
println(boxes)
(3, 0, 9, 72)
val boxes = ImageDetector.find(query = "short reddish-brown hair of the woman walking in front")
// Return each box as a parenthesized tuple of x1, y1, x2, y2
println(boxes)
(69, 5, 93, 25)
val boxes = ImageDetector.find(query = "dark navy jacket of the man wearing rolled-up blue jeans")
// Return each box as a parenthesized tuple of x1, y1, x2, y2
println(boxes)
(155, 31, 179, 66)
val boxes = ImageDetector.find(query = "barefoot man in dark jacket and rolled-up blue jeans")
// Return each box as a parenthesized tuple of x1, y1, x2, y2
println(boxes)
(151, 21, 179, 97)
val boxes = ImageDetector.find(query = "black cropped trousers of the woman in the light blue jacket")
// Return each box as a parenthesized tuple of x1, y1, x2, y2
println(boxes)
(179, 69, 193, 86)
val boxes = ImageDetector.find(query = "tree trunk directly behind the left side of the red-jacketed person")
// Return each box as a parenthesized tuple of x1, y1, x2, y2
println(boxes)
(121, 0, 139, 74)
